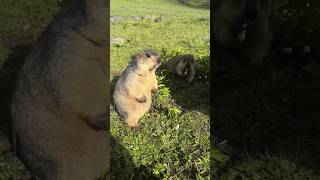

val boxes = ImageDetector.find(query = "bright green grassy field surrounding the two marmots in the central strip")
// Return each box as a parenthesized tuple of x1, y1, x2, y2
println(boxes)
(110, 0, 210, 179)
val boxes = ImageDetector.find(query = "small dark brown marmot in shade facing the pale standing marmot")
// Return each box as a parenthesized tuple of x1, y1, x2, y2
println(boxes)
(166, 54, 196, 82)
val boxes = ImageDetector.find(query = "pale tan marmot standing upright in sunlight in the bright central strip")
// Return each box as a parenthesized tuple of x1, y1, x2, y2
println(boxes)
(113, 50, 160, 127)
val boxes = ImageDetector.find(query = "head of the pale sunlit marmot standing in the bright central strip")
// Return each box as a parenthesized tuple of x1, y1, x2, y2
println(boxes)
(134, 49, 161, 73)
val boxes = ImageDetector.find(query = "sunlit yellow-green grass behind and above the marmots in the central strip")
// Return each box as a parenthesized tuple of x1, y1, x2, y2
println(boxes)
(110, 0, 210, 79)
